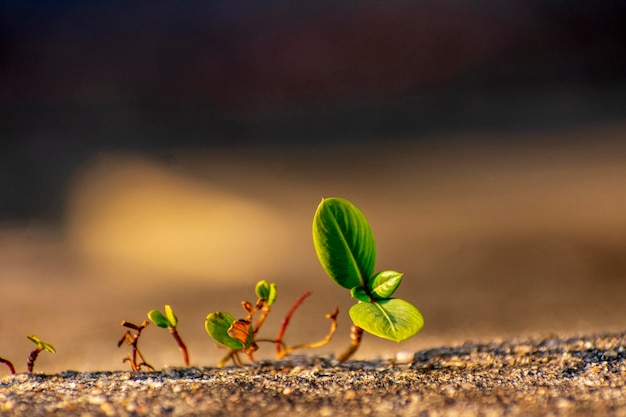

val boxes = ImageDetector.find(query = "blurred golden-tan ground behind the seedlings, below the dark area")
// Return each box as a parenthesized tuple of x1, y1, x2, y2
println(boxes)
(0, 122, 626, 375)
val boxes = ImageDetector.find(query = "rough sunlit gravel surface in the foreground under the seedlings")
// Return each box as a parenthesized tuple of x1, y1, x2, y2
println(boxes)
(0, 333, 626, 417)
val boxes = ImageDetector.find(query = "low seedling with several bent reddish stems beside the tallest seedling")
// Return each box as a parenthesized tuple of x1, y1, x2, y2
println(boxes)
(205, 280, 337, 368)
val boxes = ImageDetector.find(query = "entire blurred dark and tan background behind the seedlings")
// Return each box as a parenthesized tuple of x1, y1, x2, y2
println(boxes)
(0, 0, 626, 375)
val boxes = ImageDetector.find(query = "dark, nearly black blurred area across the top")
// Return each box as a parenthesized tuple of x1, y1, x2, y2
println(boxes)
(0, 0, 626, 222)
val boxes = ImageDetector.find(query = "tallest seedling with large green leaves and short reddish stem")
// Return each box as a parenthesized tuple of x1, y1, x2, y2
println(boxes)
(313, 198, 424, 361)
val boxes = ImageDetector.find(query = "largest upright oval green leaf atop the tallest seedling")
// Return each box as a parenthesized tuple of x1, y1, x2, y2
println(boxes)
(313, 198, 376, 289)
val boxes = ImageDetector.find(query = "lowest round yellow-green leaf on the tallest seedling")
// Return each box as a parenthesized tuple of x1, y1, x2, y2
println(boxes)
(349, 298, 424, 342)
